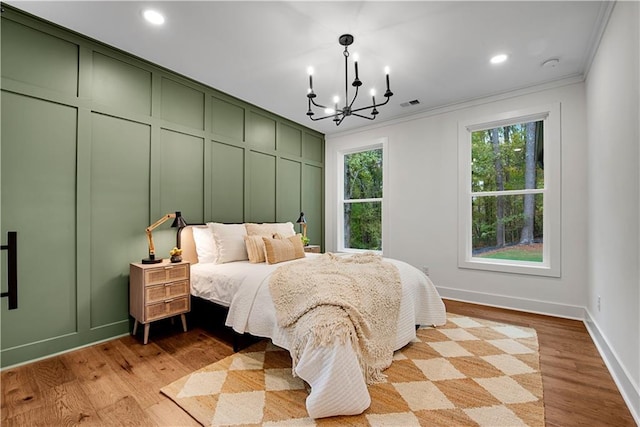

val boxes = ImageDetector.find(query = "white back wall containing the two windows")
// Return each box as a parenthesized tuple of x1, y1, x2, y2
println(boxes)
(325, 82, 588, 318)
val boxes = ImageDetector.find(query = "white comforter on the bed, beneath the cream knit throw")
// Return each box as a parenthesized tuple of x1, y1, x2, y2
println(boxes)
(191, 254, 446, 418)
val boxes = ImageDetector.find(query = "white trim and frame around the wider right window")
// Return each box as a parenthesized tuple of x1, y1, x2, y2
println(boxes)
(458, 103, 562, 277)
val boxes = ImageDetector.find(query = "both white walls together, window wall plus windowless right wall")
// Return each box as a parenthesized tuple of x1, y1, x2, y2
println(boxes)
(325, 2, 640, 424)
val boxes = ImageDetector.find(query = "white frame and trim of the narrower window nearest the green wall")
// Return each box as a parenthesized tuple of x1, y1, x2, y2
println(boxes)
(336, 137, 389, 255)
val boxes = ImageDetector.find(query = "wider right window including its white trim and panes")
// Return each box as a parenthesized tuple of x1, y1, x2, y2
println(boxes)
(458, 106, 560, 277)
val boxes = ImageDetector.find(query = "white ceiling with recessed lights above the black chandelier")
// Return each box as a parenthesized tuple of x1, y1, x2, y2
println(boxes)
(6, 0, 608, 134)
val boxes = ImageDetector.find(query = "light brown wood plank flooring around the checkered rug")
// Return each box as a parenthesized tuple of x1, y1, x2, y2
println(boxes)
(0, 300, 636, 427)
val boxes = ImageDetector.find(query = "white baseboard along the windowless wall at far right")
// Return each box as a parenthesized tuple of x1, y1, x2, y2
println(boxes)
(584, 310, 640, 426)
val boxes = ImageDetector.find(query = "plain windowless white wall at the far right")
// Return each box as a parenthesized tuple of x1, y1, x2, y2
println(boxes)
(586, 2, 640, 423)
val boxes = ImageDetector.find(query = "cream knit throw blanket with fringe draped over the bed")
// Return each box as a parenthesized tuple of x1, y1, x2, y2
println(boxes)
(269, 253, 402, 384)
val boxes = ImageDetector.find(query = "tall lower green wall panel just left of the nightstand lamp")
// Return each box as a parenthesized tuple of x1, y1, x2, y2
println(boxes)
(91, 113, 150, 327)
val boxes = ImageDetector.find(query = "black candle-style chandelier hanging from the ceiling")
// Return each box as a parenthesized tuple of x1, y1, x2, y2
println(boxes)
(307, 34, 393, 126)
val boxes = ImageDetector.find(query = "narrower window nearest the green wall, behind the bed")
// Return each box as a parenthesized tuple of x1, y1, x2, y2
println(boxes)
(338, 141, 386, 252)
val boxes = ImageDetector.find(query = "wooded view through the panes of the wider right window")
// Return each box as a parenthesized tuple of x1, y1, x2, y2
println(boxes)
(471, 120, 545, 262)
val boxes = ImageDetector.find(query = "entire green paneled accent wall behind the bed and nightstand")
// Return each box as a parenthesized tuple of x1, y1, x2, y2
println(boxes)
(0, 5, 324, 366)
